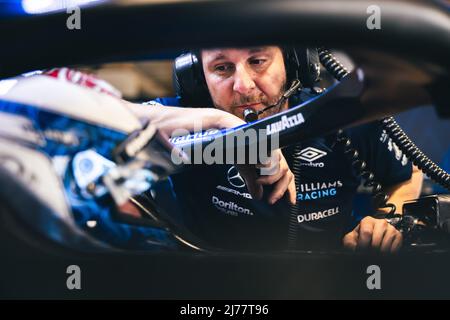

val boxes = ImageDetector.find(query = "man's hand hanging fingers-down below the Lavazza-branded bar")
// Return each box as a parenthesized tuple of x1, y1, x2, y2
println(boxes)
(237, 149, 297, 204)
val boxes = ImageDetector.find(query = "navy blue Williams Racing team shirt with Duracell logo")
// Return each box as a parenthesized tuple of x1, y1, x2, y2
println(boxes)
(150, 98, 412, 250)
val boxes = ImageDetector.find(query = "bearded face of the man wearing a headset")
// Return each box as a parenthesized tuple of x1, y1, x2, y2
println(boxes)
(202, 46, 287, 118)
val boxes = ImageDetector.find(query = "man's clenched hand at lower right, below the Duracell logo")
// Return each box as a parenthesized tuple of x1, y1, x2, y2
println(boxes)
(343, 217, 403, 253)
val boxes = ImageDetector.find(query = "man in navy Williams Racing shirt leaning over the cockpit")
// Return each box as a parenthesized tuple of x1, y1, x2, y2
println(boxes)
(143, 46, 422, 252)
